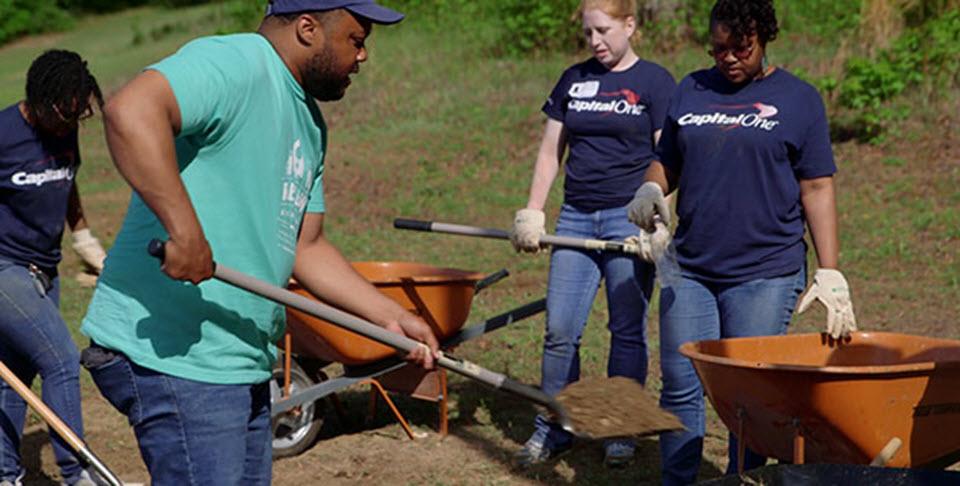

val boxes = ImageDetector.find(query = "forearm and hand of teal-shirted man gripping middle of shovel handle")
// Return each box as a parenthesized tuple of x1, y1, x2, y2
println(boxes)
(293, 213, 439, 368)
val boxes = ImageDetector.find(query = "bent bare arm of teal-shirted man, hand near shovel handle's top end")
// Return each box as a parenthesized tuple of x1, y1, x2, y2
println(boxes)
(103, 70, 213, 283)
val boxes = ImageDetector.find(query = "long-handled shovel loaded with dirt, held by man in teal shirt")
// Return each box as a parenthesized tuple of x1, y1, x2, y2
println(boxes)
(147, 240, 683, 438)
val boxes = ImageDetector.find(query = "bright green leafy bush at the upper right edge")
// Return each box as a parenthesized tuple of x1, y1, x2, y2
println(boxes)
(839, 10, 960, 139)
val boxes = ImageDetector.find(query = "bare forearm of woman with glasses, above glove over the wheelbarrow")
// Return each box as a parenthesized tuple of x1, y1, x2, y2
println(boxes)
(800, 176, 840, 269)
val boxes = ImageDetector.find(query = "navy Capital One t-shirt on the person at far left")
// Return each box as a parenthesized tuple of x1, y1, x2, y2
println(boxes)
(0, 104, 80, 275)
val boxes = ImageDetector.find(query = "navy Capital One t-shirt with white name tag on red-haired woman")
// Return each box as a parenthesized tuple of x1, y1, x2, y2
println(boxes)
(543, 58, 676, 211)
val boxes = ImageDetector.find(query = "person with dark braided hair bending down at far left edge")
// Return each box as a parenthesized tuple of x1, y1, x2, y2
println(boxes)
(0, 50, 103, 485)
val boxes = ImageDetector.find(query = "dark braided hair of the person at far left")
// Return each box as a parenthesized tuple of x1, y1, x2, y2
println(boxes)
(26, 49, 103, 129)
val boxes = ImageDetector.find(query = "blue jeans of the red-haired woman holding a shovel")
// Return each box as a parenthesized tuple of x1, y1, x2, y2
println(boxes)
(533, 204, 654, 448)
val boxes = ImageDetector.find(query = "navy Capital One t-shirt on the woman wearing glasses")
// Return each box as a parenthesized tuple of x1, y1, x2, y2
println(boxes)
(658, 69, 836, 283)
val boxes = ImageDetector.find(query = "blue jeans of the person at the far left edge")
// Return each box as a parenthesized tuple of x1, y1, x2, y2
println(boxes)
(0, 260, 83, 484)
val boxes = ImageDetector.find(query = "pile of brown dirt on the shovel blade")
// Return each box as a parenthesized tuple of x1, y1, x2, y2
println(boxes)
(557, 377, 683, 439)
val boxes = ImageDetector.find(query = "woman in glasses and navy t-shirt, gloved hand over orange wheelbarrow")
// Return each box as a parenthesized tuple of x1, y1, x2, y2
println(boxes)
(629, 0, 855, 484)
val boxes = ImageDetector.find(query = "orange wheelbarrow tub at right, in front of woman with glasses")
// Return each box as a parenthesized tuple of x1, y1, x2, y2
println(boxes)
(680, 332, 960, 470)
